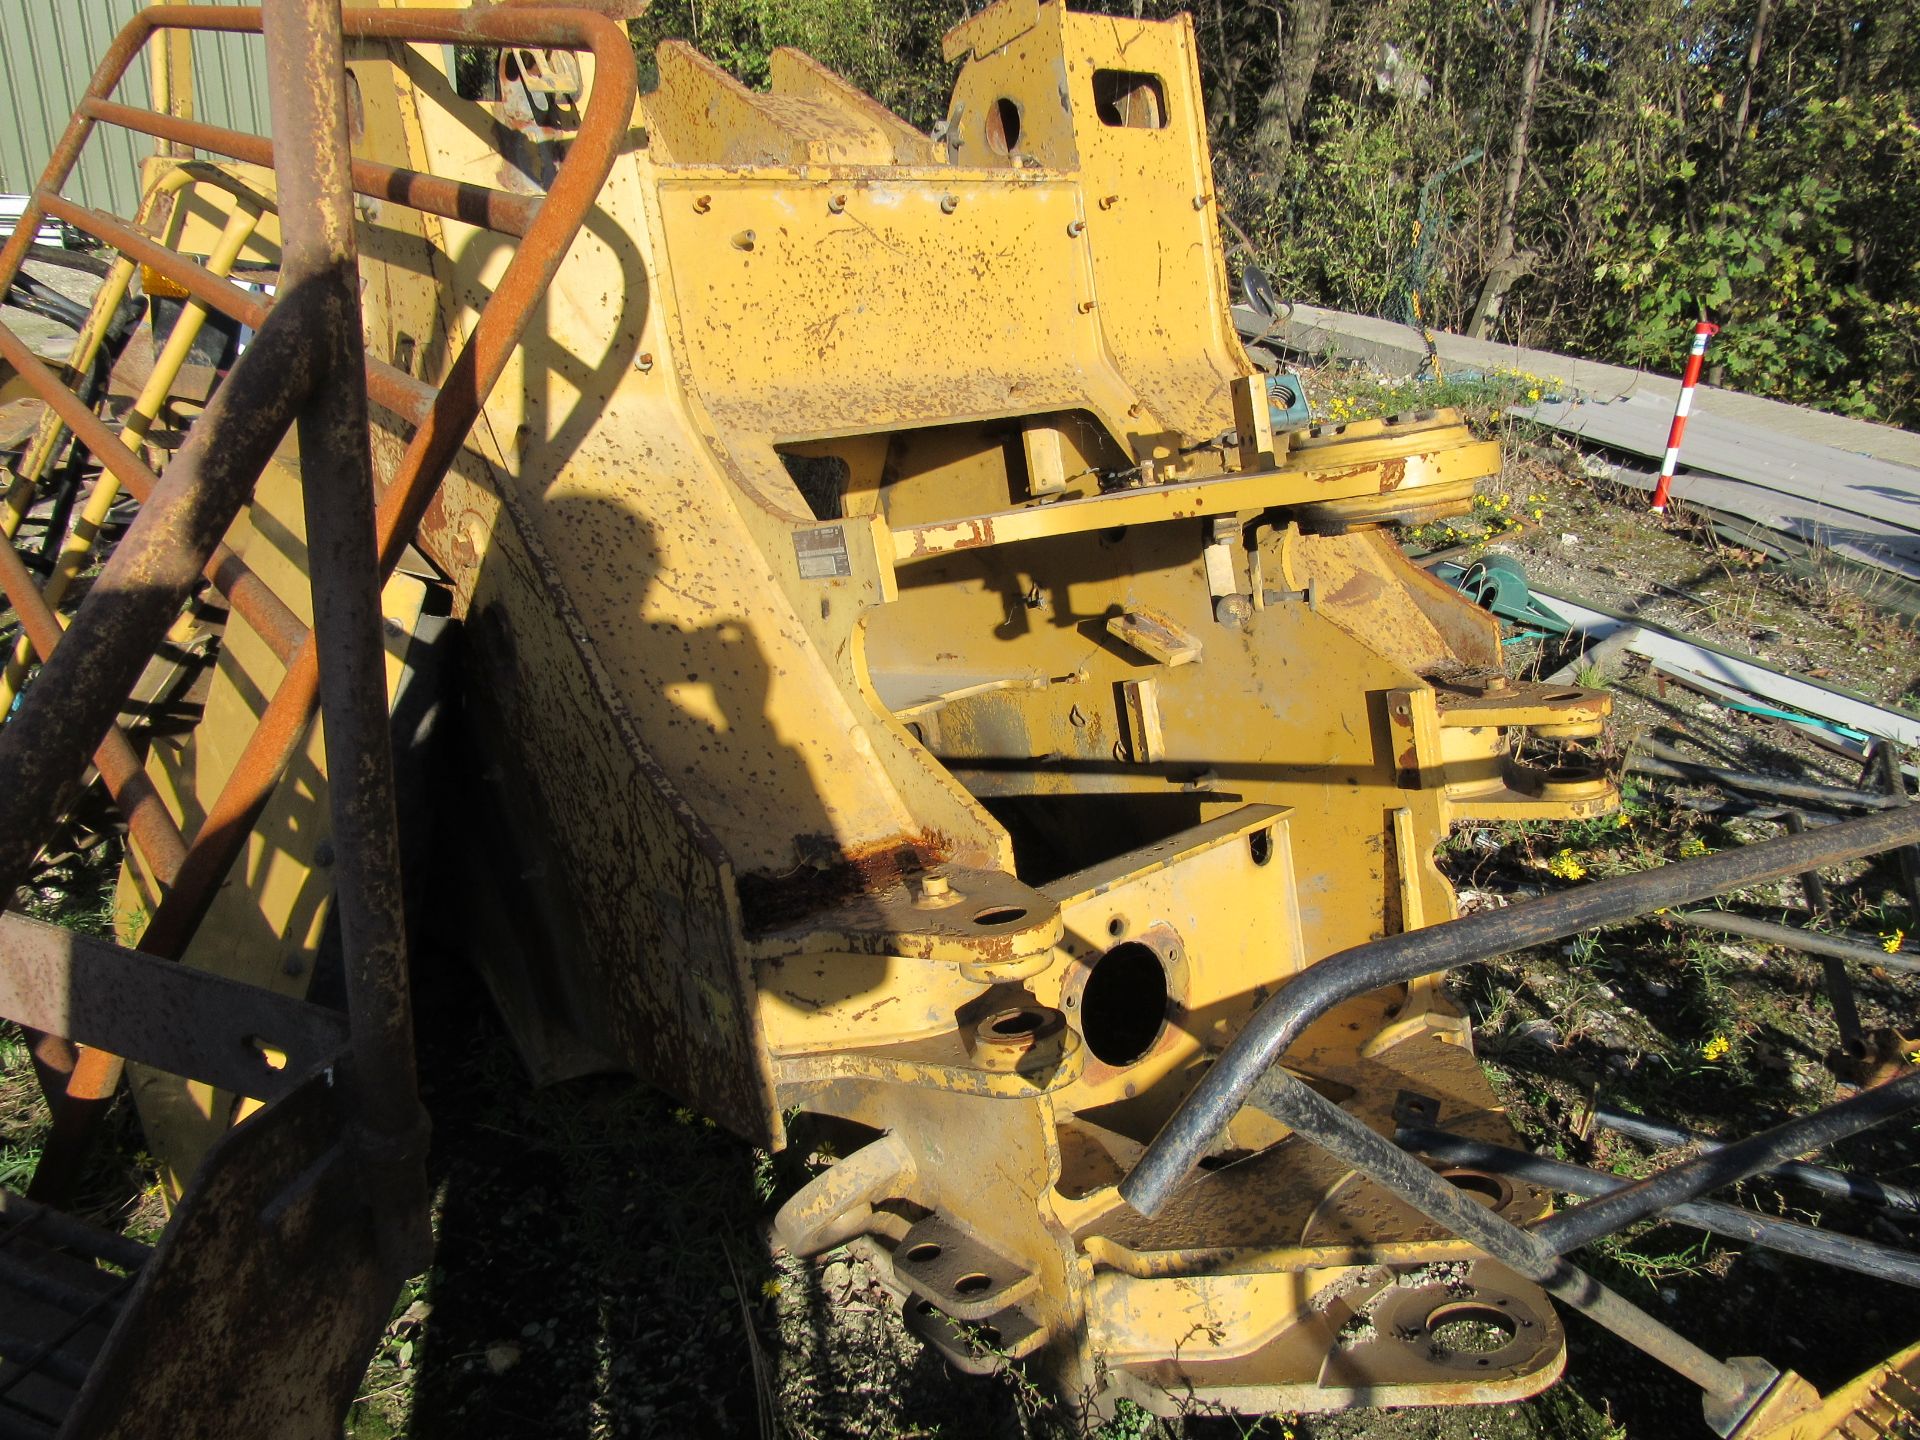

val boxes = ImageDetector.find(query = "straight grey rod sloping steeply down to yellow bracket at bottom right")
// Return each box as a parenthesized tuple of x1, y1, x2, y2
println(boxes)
(1261, 1069, 1759, 1413)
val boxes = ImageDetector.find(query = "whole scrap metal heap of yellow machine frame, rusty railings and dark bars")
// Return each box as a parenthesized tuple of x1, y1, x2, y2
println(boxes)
(0, 0, 1920, 1436)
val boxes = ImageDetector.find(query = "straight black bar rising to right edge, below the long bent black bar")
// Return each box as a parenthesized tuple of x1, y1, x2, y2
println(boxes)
(1534, 1071, 1920, 1254)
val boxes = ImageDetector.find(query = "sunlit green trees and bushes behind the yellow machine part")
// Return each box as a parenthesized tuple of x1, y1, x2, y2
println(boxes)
(634, 0, 1920, 424)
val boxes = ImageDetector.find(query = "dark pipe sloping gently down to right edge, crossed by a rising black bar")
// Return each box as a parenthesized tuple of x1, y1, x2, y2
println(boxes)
(1394, 1127, 1920, 1288)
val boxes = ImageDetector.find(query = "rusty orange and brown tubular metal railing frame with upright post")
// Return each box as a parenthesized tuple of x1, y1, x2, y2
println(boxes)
(0, 0, 637, 1440)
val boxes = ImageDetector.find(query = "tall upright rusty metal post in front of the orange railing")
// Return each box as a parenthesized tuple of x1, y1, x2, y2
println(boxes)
(263, 0, 432, 1269)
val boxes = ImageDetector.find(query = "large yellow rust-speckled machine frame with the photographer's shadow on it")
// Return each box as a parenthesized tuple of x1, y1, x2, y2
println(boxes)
(123, 0, 1617, 1411)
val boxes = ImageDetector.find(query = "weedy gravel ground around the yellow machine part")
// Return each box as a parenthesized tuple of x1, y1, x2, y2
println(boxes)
(0, 360, 1920, 1440)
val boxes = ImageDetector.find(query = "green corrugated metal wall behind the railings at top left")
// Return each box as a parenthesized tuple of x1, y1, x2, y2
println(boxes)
(0, 0, 269, 215)
